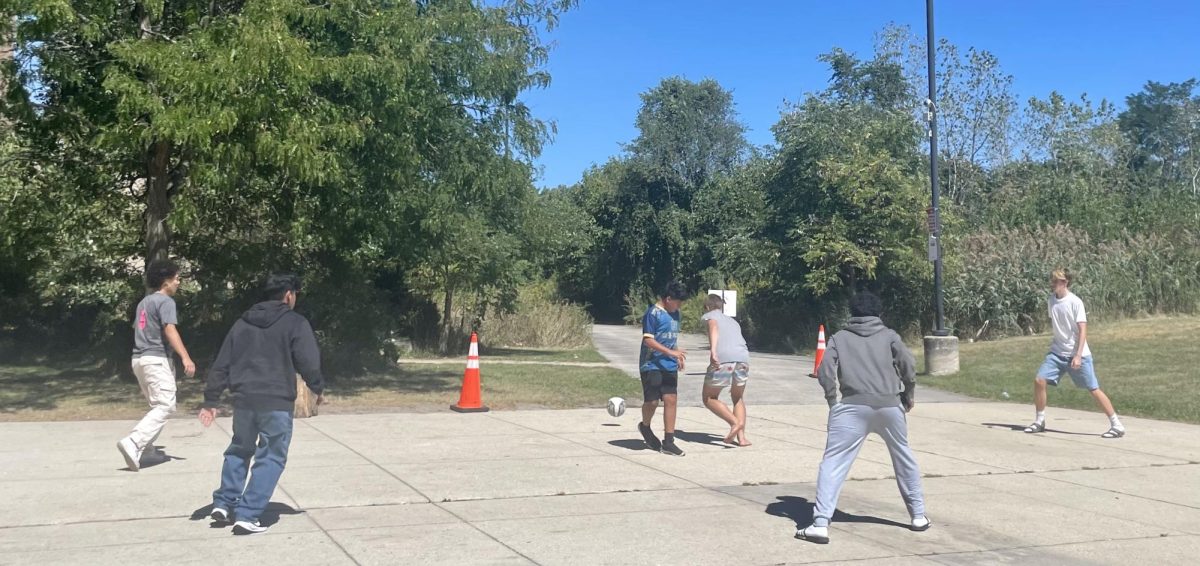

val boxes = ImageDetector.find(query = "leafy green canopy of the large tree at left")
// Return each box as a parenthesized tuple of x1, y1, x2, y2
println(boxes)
(4, 0, 574, 362)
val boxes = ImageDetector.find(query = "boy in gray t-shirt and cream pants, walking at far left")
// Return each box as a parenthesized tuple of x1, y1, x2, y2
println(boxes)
(116, 261, 196, 471)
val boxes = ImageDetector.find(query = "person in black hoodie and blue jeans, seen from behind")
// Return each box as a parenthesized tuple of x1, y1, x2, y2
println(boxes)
(199, 275, 325, 535)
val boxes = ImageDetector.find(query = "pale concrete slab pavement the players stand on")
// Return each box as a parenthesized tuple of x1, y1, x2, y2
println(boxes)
(0, 403, 1200, 566)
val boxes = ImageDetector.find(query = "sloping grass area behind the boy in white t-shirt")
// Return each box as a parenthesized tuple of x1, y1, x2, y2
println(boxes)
(917, 317, 1200, 423)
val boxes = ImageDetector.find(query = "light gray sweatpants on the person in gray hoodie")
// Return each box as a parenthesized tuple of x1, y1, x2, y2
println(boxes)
(812, 403, 925, 526)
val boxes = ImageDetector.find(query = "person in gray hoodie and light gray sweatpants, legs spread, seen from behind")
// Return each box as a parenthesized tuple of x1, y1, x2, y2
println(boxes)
(796, 293, 930, 544)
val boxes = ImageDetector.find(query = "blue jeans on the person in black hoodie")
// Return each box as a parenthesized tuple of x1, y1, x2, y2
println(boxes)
(212, 409, 292, 522)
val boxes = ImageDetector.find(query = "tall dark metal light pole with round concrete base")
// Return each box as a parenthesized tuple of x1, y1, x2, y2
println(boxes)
(924, 0, 959, 375)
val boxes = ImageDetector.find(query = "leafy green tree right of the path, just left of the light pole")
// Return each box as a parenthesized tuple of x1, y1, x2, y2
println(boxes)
(767, 50, 925, 303)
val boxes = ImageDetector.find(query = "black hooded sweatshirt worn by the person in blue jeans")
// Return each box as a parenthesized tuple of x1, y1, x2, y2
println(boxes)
(204, 301, 325, 413)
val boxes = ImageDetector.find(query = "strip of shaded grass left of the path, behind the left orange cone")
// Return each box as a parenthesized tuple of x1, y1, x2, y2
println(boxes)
(0, 353, 641, 421)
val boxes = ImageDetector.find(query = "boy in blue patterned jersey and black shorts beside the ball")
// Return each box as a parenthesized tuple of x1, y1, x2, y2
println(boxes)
(637, 281, 688, 456)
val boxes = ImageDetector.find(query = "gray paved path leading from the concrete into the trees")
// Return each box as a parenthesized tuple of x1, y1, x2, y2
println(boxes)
(592, 325, 972, 410)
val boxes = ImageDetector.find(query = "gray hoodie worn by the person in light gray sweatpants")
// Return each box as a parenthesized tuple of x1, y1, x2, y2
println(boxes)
(817, 317, 917, 408)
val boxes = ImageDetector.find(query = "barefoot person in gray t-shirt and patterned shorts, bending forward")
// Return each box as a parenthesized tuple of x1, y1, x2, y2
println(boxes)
(700, 295, 750, 446)
